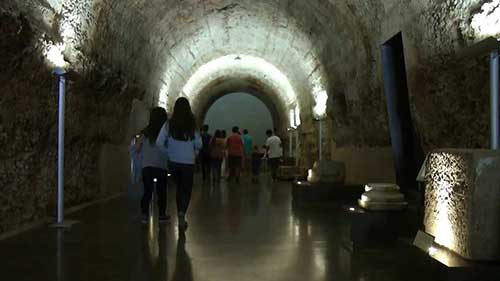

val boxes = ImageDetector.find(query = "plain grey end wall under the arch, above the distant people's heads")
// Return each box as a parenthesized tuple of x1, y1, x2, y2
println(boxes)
(203, 92, 275, 146)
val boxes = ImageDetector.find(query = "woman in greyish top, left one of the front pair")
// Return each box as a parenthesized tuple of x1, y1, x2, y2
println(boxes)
(135, 107, 168, 223)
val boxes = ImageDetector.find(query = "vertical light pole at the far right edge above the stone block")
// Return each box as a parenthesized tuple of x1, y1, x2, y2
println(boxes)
(490, 49, 499, 149)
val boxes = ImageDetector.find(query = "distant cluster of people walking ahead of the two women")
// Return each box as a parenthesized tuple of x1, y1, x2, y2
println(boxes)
(200, 125, 283, 184)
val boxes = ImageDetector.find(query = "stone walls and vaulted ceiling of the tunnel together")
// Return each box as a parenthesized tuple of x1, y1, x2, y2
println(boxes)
(0, 0, 500, 280)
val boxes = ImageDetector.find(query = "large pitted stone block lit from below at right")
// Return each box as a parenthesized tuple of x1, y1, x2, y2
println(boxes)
(424, 149, 500, 261)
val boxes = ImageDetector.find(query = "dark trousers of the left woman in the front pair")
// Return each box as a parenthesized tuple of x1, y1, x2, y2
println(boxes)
(141, 167, 167, 215)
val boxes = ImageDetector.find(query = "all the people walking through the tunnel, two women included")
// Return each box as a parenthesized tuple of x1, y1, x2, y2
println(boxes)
(131, 97, 282, 228)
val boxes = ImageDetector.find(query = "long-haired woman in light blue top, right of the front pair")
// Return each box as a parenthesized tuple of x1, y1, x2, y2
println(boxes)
(156, 98, 203, 231)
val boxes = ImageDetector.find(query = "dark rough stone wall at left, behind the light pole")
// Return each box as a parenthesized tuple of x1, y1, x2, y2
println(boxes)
(0, 13, 140, 233)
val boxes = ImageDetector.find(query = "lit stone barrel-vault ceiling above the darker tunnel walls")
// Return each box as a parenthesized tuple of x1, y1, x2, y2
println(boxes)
(0, 0, 500, 132)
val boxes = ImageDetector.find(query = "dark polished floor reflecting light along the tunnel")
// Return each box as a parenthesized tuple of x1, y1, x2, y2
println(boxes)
(0, 174, 433, 281)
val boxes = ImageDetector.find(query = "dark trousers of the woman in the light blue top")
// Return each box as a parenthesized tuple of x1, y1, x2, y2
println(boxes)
(168, 162, 194, 214)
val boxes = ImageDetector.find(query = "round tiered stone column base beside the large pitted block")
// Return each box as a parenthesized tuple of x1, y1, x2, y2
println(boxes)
(358, 183, 408, 211)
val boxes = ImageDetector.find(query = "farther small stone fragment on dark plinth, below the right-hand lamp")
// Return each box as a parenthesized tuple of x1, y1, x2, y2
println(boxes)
(307, 160, 345, 184)
